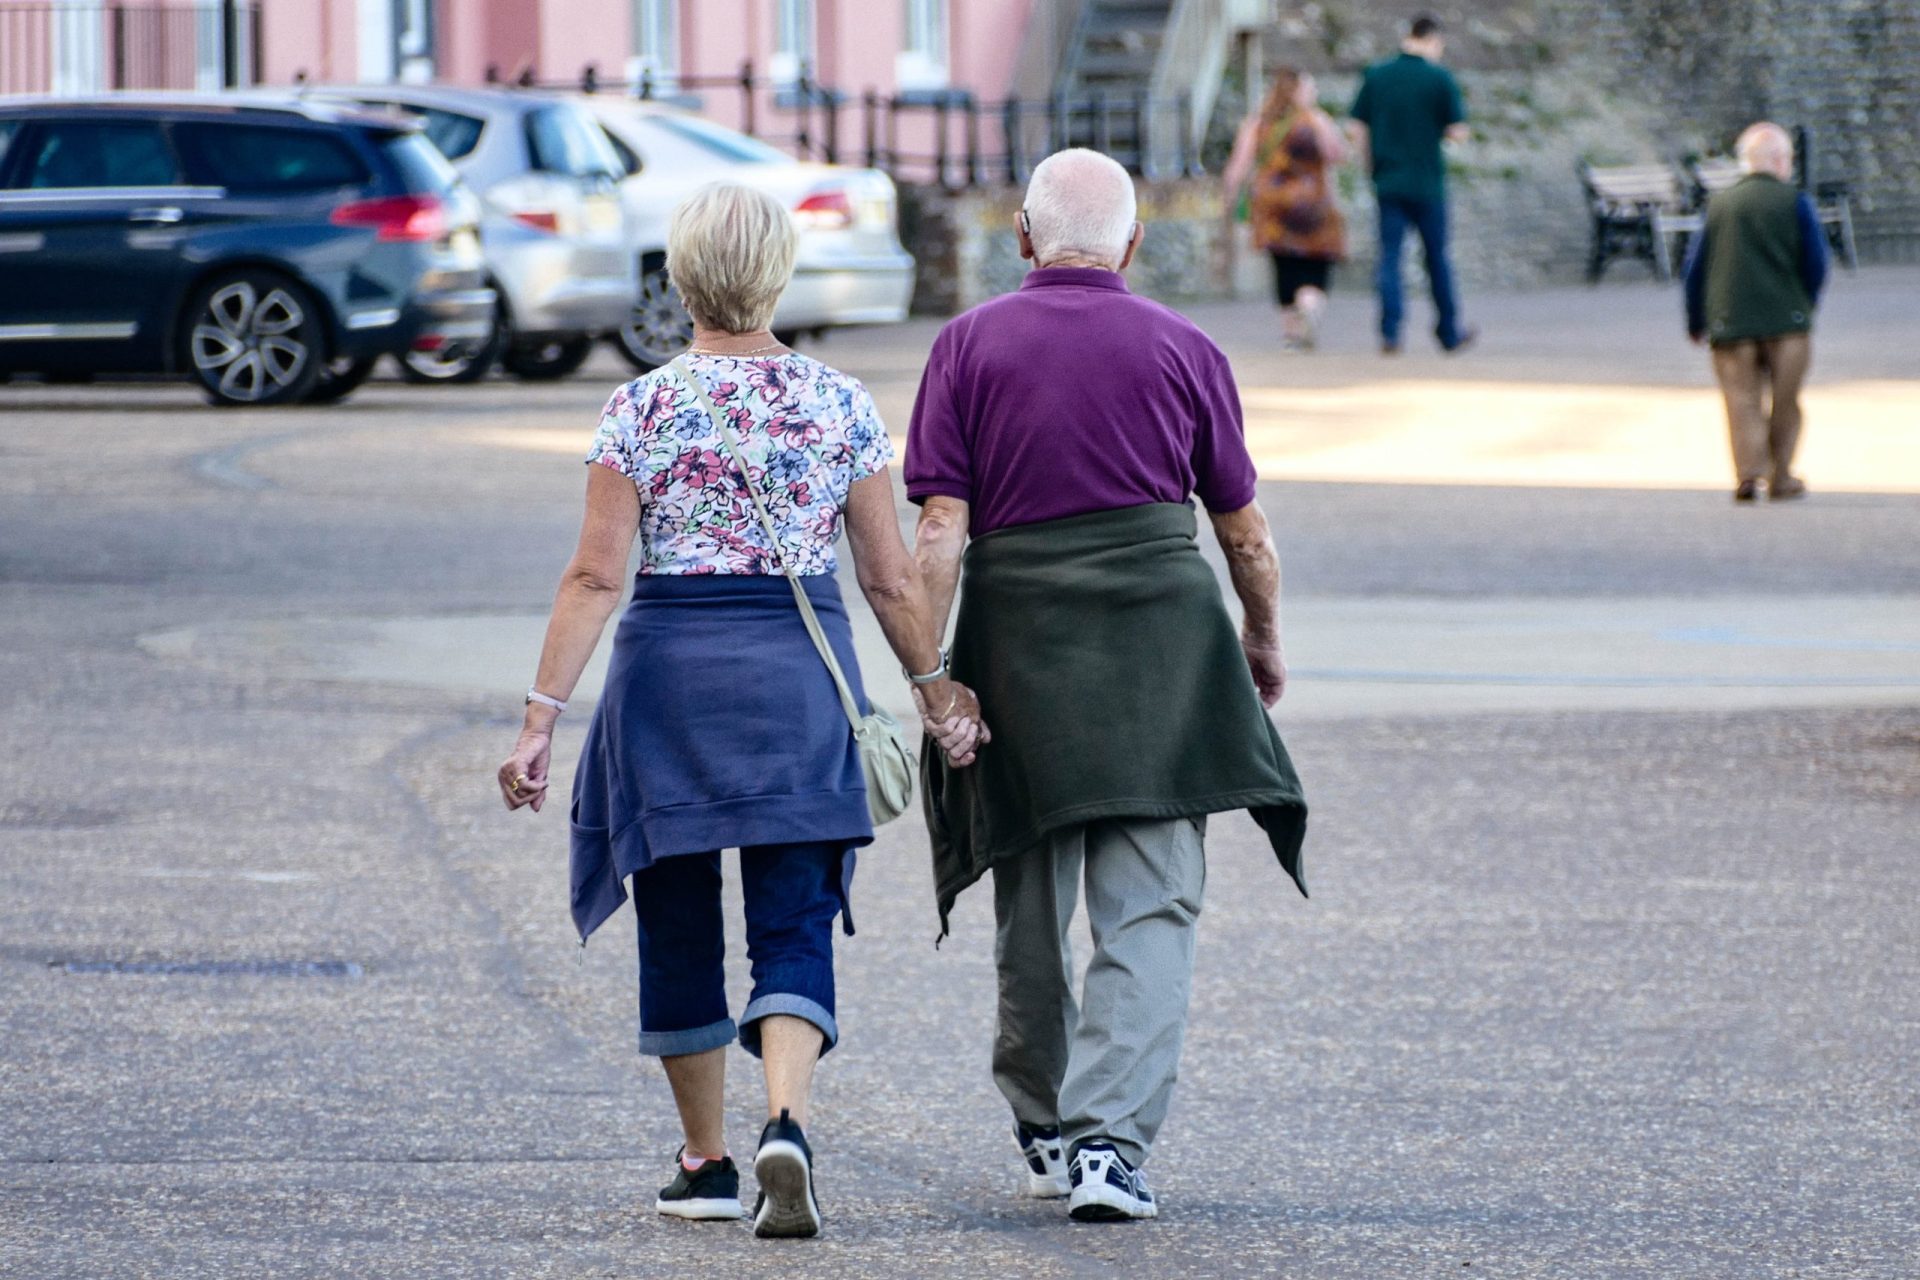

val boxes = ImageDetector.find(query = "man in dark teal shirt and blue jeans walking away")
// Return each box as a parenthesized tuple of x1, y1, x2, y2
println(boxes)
(1350, 15, 1476, 355)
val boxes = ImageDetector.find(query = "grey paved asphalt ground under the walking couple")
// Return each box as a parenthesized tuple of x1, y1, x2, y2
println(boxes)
(0, 273, 1920, 1280)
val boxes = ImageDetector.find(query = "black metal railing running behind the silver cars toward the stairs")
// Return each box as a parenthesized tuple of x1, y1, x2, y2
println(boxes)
(486, 61, 1204, 190)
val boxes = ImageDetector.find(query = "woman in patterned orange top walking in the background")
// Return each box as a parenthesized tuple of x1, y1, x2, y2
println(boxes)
(1225, 67, 1348, 351)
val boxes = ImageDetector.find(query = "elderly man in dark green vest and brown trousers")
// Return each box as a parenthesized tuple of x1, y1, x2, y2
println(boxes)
(1686, 121, 1828, 503)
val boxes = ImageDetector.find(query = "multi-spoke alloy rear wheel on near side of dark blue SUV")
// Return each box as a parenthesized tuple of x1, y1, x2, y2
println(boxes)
(184, 267, 323, 405)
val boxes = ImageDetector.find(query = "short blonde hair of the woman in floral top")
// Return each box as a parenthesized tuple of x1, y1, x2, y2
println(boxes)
(666, 182, 797, 334)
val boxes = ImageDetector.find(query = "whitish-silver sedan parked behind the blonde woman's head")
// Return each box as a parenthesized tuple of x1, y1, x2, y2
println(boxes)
(574, 96, 914, 372)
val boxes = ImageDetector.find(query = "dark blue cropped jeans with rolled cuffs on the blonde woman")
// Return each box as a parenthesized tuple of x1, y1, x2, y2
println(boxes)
(634, 842, 854, 1057)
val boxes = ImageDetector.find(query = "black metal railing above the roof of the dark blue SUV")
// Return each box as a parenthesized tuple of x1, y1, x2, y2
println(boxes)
(0, 0, 261, 94)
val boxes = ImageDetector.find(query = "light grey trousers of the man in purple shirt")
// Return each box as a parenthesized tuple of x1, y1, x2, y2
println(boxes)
(993, 818, 1206, 1167)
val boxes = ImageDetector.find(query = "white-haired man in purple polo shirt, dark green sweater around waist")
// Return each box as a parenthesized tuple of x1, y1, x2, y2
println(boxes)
(906, 150, 1306, 1221)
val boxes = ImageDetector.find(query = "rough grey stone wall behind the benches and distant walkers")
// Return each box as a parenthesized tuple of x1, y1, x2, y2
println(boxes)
(902, 0, 1920, 315)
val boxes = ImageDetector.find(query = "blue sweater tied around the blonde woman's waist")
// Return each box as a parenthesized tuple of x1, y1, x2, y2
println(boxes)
(572, 574, 874, 942)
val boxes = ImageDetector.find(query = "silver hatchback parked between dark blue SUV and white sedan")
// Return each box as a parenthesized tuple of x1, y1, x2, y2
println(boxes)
(307, 84, 637, 382)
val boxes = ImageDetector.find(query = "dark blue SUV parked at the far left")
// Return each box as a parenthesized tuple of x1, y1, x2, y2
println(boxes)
(0, 96, 493, 405)
